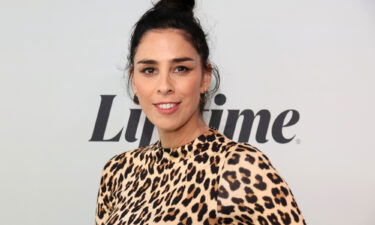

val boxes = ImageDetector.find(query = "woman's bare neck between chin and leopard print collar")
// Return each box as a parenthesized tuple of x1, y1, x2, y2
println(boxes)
(158, 118, 209, 148)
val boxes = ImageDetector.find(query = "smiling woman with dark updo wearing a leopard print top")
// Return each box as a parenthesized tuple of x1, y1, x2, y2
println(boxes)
(96, 0, 305, 225)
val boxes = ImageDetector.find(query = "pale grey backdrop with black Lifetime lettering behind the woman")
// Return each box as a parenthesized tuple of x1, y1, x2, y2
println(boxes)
(0, 0, 375, 225)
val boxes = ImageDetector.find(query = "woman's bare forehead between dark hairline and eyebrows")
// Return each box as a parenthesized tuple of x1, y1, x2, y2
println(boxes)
(134, 29, 199, 60)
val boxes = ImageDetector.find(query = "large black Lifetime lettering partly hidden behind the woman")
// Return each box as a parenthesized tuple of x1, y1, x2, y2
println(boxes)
(89, 94, 300, 147)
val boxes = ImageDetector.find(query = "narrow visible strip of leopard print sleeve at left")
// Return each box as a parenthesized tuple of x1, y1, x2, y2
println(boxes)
(95, 156, 116, 225)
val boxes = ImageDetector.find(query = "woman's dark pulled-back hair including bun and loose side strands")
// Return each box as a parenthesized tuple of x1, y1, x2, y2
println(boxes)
(126, 0, 220, 113)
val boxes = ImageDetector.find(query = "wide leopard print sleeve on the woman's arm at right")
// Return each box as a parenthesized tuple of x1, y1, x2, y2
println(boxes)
(218, 143, 306, 225)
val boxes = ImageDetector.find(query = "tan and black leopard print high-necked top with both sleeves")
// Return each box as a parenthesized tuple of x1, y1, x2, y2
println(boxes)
(95, 128, 306, 225)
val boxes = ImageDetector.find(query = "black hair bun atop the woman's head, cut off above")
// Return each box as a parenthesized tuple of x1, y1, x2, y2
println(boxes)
(154, 0, 195, 13)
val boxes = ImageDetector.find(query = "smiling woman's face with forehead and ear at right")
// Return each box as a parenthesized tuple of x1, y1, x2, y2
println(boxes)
(132, 29, 211, 131)
